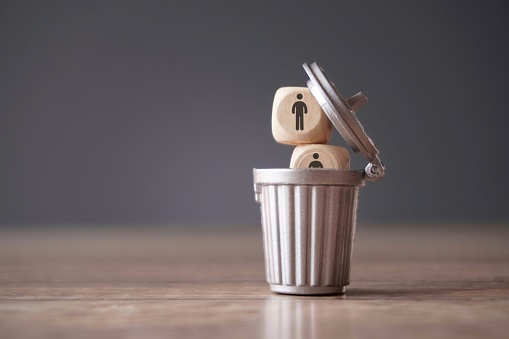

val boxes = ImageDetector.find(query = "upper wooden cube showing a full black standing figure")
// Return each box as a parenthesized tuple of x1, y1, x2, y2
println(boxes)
(272, 87, 332, 145)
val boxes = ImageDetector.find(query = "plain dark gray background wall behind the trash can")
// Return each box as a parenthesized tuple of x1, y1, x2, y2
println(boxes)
(0, 0, 509, 226)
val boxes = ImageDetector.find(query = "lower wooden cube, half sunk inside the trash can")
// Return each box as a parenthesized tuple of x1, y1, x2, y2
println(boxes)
(290, 144, 350, 169)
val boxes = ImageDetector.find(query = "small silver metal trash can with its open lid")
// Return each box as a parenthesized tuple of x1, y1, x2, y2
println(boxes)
(253, 63, 384, 295)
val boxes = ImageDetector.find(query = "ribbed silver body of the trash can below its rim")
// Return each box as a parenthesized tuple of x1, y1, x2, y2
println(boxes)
(259, 184, 359, 294)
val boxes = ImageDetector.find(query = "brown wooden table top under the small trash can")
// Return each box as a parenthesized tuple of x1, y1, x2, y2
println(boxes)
(0, 224, 509, 339)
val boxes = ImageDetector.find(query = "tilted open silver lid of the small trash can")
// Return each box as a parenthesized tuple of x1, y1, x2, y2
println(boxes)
(302, 62, 384, 180)
